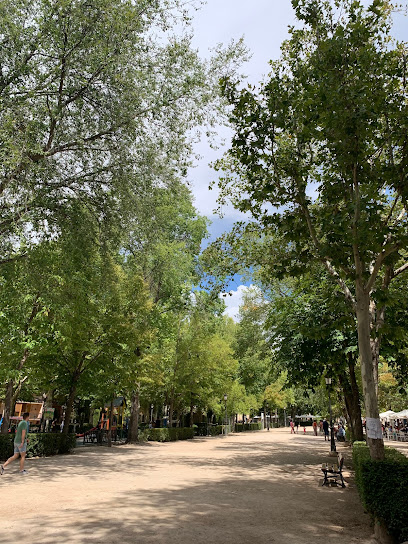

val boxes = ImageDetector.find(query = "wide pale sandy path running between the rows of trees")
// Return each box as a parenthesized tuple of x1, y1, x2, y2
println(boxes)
(0, 429, 372, 544)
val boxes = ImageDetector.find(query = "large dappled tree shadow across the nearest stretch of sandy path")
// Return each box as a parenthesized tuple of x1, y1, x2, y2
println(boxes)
(0, 475, 370, 544)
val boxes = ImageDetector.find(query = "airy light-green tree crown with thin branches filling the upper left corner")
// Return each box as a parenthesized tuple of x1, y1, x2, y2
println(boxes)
(0, 0, 242, 264)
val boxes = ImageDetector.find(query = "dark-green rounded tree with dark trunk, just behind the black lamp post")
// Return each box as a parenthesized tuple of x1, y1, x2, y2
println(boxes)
(265, 273, 363, 440)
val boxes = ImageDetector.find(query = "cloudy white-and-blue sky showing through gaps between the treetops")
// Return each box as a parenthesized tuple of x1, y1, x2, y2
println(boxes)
(189, 0, 408, 318)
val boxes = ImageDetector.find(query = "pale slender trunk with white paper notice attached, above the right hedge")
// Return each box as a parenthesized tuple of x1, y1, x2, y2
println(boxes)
(356, 280, 384, 460)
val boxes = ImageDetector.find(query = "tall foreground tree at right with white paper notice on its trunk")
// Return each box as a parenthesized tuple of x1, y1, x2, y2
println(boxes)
(218, 0, 408, 459)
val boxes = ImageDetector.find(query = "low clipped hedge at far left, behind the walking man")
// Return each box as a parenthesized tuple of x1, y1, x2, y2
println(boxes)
(0, 433, 76, 461)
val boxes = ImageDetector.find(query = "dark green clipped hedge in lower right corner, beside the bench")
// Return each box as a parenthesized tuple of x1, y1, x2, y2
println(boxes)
(353, 442, 408, 542)
